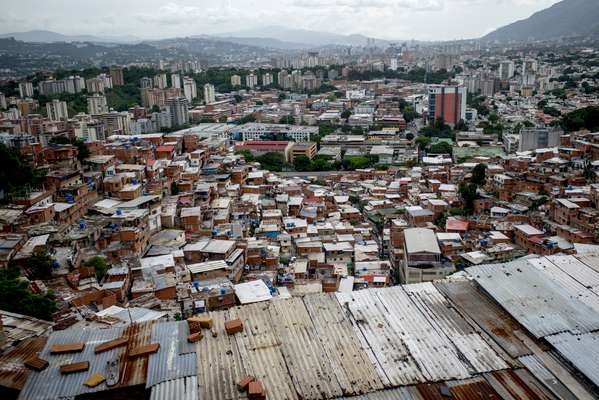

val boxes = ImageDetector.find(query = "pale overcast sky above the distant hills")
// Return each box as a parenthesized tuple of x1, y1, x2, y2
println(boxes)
(0, 0, 558, 40)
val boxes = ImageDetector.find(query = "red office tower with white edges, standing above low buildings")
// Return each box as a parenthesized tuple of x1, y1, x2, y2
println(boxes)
(428, 85, 468, 126)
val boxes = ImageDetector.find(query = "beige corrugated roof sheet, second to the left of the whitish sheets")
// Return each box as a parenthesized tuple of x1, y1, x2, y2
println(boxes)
(267, 297, 343, 399)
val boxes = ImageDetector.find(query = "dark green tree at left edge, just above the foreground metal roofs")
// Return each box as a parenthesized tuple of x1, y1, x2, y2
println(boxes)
(0, 267, 56, 321)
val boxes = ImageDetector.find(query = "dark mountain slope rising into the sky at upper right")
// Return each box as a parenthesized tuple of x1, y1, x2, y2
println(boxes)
(482, 0, 599, 41)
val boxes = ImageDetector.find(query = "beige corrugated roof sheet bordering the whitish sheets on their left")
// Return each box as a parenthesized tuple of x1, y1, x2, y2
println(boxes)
(303, 294, 383, 395)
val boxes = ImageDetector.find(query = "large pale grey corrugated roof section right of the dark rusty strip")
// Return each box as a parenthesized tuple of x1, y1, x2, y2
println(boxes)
(467, 260, 599, 338)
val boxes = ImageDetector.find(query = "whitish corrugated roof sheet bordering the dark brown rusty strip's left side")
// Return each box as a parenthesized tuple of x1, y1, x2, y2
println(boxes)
(404, 282, 508, 373)
